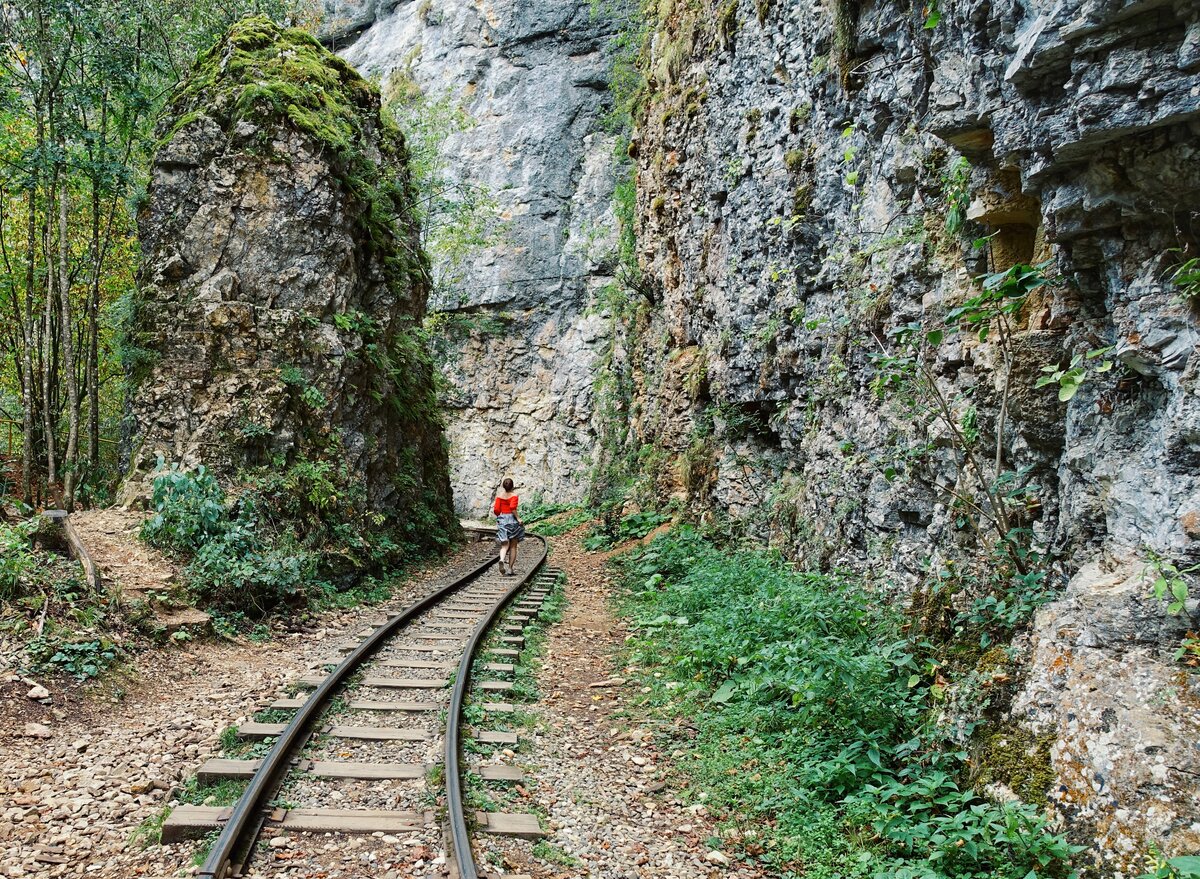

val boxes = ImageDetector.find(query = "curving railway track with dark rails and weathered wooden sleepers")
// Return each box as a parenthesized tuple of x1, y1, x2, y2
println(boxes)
(162, 537, 558, 879)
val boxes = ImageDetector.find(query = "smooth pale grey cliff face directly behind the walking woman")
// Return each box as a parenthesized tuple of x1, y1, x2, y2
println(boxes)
(325, 0, 616, 515)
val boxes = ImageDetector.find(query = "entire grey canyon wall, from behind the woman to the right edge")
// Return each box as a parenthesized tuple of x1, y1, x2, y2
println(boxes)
(325, 0, 1200, 875)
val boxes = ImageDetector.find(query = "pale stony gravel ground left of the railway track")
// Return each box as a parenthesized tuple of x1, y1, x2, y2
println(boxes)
(0, 544, 494, 877)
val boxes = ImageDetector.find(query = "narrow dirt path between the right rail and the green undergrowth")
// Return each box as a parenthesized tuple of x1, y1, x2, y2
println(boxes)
(480, 530, 762, 879)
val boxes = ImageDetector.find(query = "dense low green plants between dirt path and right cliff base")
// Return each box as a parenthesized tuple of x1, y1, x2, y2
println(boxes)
(623, 527, 1073, 879)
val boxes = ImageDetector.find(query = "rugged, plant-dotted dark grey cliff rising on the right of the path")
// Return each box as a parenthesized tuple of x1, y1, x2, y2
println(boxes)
(622, 0, 1200, 875)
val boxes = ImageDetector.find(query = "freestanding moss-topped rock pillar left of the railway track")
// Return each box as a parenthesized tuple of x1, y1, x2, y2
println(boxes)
(128, 19, 452, 538)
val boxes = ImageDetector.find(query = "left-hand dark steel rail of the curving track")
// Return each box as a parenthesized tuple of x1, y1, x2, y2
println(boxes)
(194, 549, 496, 879)
